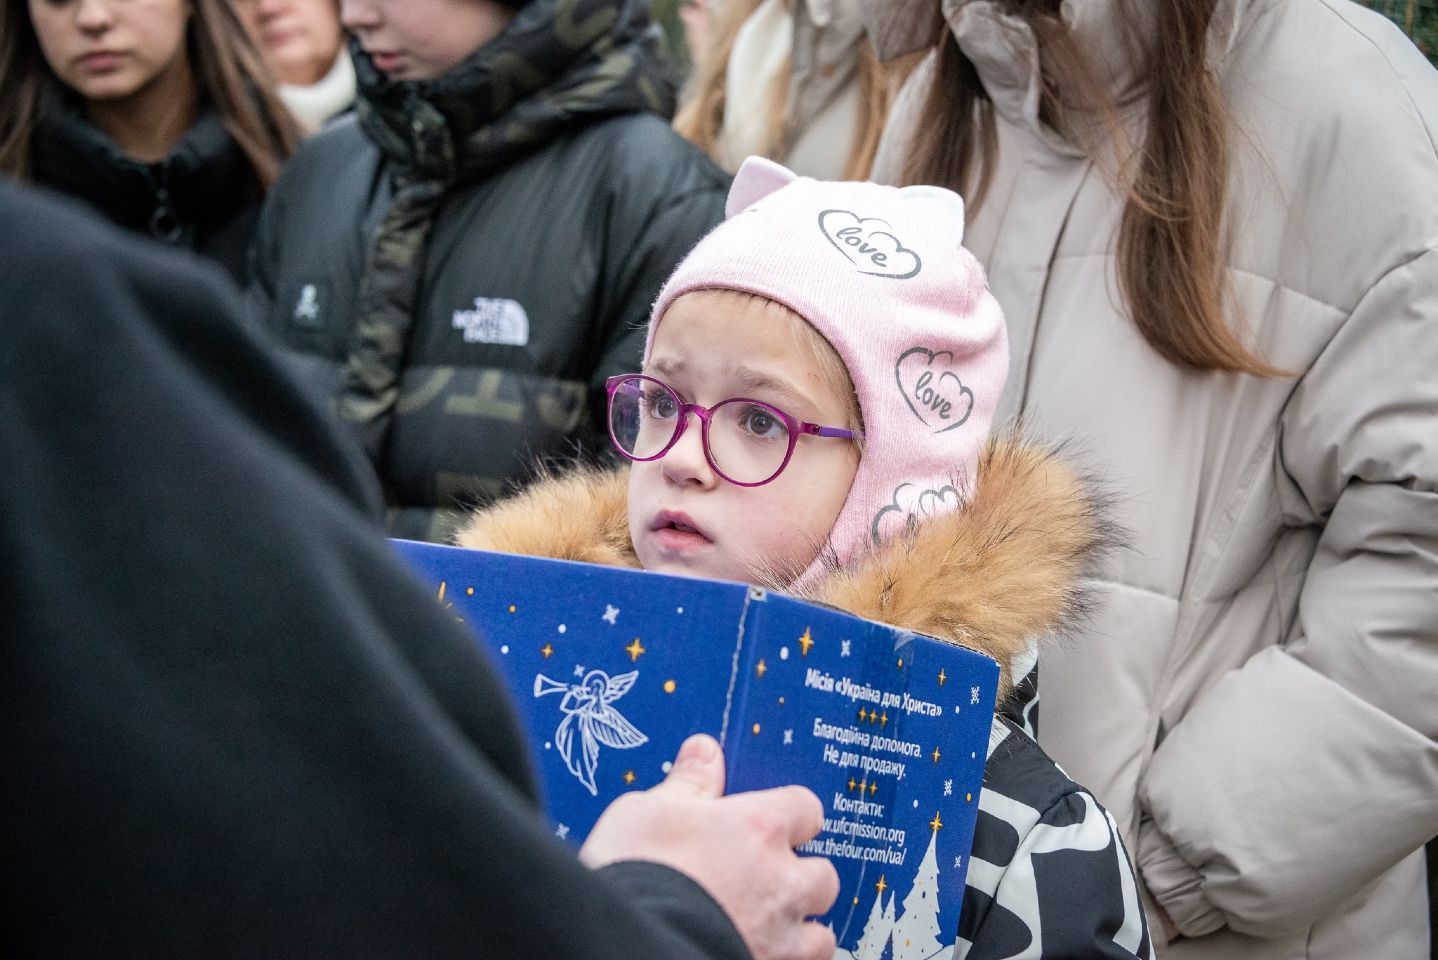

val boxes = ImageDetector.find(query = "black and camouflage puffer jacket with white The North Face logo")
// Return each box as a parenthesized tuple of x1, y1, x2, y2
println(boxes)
(250, 0, 728, 540)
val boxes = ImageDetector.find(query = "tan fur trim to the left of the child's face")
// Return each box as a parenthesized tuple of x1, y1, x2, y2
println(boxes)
(454, 469, 638, 566)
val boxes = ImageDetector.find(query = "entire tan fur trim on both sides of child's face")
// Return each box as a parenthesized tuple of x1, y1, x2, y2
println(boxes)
(454, 438, 1113, 703)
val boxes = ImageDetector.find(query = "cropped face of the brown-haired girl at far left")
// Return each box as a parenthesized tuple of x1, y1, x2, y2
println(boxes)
(29, 0, 191, 101)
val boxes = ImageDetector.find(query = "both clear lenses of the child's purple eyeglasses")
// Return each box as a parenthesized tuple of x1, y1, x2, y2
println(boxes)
(610, 377, 789, 483)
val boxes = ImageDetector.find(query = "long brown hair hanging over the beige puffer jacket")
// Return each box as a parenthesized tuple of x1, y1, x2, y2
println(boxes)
(902, 0, 1286, 377)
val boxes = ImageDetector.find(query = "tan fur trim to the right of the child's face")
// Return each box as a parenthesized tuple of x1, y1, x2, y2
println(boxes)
(807, 440, 1107, 701)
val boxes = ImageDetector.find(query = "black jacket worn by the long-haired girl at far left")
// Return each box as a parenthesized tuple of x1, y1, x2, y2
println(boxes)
(30, 93, 265, 283)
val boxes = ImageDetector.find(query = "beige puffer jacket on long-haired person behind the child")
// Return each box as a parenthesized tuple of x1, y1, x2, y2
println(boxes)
(879, 0, 1438, 960)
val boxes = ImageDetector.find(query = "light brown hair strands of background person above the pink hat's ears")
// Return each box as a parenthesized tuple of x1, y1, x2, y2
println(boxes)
(674, 0, 896, 180)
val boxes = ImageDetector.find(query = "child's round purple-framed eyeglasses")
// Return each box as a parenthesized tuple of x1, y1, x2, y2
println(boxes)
(604, 374, 858, 487)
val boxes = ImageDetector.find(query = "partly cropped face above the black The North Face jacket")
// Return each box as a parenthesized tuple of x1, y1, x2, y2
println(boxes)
(339, 0, 515, 80)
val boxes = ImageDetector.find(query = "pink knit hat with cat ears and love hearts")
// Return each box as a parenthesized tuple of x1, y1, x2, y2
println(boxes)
(644, 157, 1008, 591)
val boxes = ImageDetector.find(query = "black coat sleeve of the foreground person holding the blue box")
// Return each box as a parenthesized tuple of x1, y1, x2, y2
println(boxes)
(0, 185, 746, 960)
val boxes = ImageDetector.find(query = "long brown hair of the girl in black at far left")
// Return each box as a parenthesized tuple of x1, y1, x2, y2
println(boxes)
(0, 0, 299, 190)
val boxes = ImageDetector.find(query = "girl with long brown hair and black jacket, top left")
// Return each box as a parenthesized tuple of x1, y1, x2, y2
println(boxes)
(0, 0, 298, 280)
